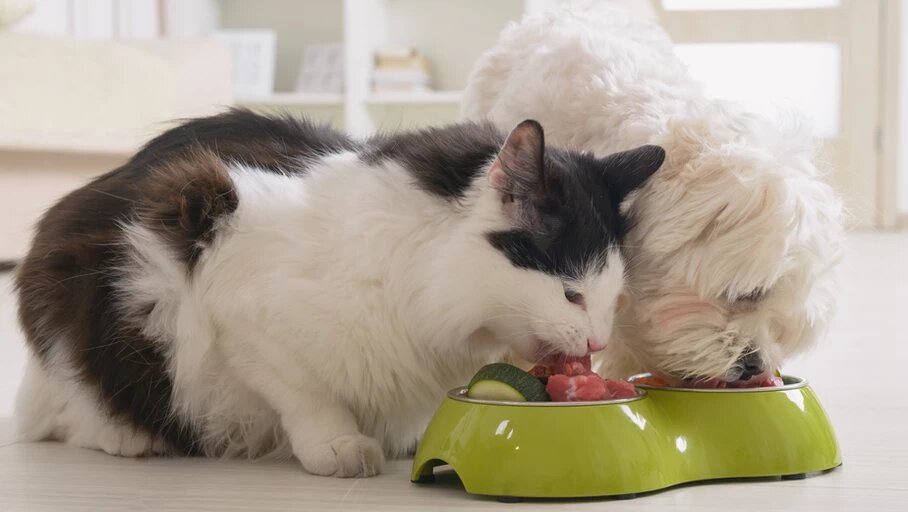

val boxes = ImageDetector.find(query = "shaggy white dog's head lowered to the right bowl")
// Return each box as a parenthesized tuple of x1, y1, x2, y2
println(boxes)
(616, 113, 841, 381)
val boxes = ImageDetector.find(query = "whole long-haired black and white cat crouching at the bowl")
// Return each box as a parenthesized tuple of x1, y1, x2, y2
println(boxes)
(10, 110, 664, 476)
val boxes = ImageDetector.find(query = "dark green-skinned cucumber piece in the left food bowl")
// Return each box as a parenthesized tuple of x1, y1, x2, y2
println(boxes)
(467, 363, 549, 402)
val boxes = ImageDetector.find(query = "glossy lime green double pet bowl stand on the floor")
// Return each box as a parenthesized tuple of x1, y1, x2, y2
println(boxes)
(411, 375, 842, 498)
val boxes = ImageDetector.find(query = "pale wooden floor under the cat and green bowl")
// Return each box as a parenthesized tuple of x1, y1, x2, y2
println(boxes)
(0, 234, 908, 512)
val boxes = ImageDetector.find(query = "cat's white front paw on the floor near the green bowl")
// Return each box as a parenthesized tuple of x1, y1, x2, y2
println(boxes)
(299, 434, 385, 478)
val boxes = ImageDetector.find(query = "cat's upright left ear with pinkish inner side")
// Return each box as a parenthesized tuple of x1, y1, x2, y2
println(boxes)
(489, 119, 545, 203)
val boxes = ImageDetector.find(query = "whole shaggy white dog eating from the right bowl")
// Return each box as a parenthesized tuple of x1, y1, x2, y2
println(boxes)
(462, 5, 842, 381)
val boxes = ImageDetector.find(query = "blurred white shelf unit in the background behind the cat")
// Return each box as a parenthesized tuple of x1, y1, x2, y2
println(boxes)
(218, 0, 559, 136)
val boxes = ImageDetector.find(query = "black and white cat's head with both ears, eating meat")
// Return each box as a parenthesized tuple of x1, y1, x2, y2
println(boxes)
(469, 120, 665, 361)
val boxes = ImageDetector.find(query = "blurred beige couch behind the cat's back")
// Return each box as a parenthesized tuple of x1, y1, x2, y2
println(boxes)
(0, 32, 233, 259)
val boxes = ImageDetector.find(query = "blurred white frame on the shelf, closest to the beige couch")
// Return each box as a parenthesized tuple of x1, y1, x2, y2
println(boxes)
(214, 30, 277, 98)
